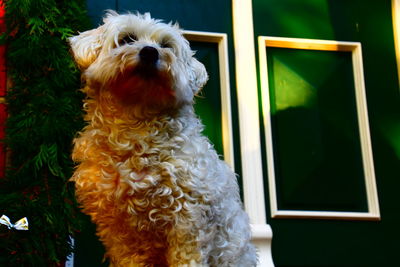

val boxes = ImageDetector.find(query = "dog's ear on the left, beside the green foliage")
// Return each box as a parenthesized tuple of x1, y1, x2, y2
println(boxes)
(68, 27, 103, 69)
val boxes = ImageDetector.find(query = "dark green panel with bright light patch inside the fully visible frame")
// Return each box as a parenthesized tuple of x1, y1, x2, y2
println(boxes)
(267, 48, 368, 212)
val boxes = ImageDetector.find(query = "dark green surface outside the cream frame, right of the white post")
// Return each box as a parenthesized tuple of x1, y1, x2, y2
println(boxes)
(253, 0, 400, 267)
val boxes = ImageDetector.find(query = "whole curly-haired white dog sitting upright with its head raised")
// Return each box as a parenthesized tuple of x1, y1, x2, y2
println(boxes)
(69, 11, 257, 267)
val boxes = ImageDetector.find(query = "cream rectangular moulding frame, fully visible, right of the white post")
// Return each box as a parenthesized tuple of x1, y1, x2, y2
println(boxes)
(258, 36, 380, 220)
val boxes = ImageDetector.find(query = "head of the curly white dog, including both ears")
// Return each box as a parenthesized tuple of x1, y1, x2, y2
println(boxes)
(69, 11, 208, 112)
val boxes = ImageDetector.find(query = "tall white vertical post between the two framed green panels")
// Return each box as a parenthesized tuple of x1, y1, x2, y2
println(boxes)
(232, 0, 274, 267)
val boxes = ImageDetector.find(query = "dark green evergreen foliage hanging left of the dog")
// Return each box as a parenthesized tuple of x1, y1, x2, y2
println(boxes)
(0, 0, 88, 266)
